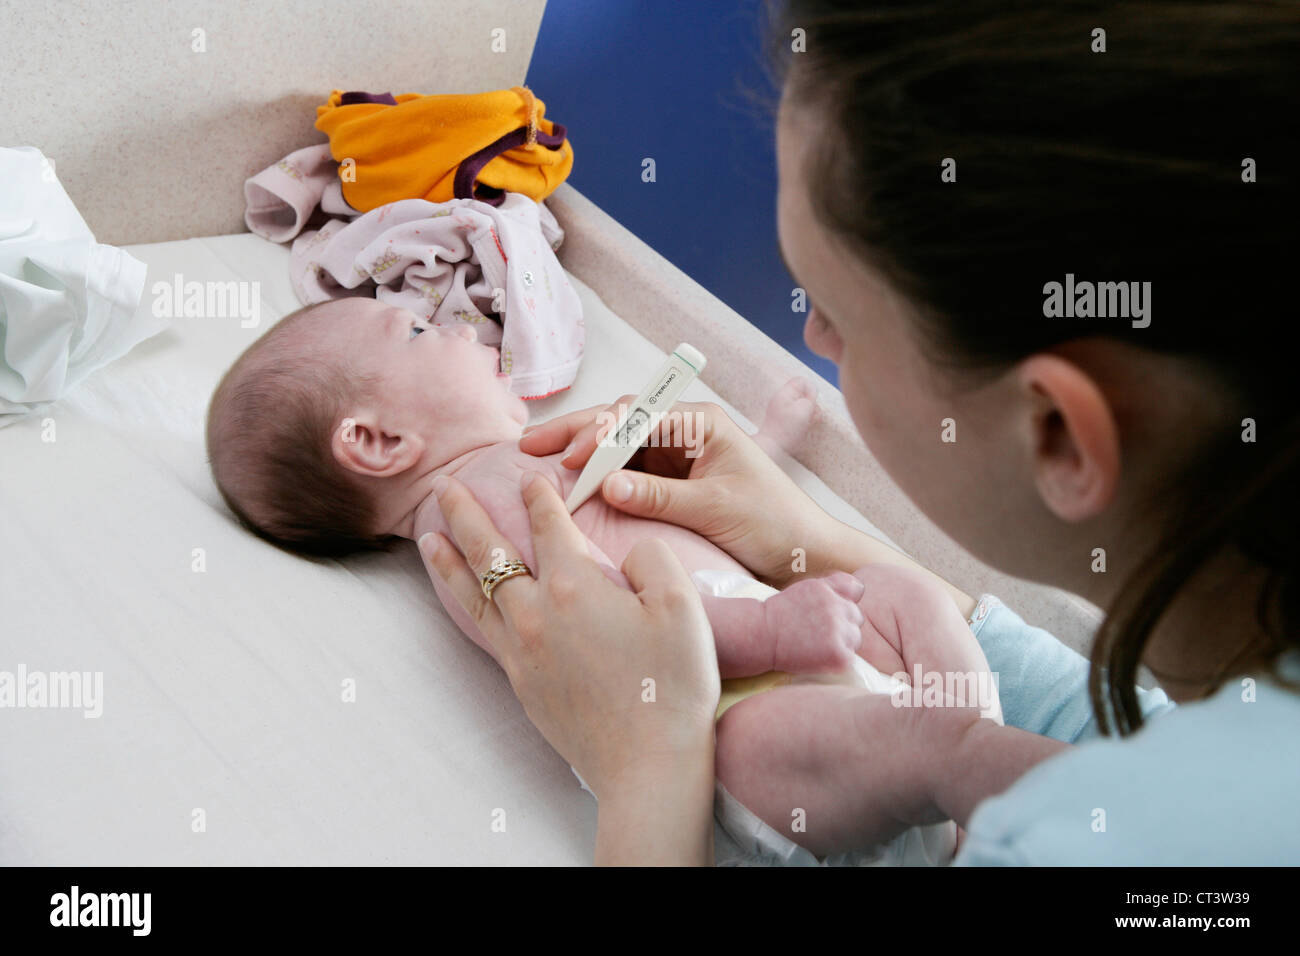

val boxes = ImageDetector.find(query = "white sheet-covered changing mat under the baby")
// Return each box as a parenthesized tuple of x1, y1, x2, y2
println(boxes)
(0, 234, 909, 865)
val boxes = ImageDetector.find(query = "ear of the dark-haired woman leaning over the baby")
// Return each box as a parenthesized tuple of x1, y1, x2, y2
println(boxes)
(1018, 354, 1119, 522)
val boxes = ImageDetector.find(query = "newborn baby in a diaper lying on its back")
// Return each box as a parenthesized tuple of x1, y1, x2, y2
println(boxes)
(207, 297, 1001, 862)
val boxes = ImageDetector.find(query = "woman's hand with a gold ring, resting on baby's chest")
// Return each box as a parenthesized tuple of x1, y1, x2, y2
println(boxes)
(420, 472, 720, 864)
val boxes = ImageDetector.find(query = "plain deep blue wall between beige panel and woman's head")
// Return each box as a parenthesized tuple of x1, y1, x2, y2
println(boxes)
(528, 0, 837, 382)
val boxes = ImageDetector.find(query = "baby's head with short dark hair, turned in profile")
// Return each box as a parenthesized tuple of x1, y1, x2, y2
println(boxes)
(208, 297, 528, 555)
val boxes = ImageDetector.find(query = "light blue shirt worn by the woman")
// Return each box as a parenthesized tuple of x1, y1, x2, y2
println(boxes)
(956, 594, 1300, 866)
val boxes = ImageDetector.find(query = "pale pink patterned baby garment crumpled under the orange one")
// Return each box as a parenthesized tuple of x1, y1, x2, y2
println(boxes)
(244, 144, 585, 398)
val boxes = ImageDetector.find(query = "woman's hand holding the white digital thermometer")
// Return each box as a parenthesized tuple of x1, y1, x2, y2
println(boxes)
(519, 395, 831, 588)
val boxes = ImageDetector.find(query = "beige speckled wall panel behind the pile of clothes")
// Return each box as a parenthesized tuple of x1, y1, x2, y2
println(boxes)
(0, 0, 546, 245)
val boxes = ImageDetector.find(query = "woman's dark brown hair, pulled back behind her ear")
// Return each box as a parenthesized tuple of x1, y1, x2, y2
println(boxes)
(768, 0, 1300, 734)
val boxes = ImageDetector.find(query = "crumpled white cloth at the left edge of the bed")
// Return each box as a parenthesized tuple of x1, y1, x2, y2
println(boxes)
(0, 146, 156, 427)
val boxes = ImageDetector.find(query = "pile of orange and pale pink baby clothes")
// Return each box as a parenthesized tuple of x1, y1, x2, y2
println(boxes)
(244, 86, 585, 398)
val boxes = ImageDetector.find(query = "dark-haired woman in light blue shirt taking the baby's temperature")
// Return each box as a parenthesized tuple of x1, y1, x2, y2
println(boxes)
(421, 0, 1300, 864)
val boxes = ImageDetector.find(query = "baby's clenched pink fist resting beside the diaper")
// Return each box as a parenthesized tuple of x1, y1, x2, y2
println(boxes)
(763, 571, 863, 674)
